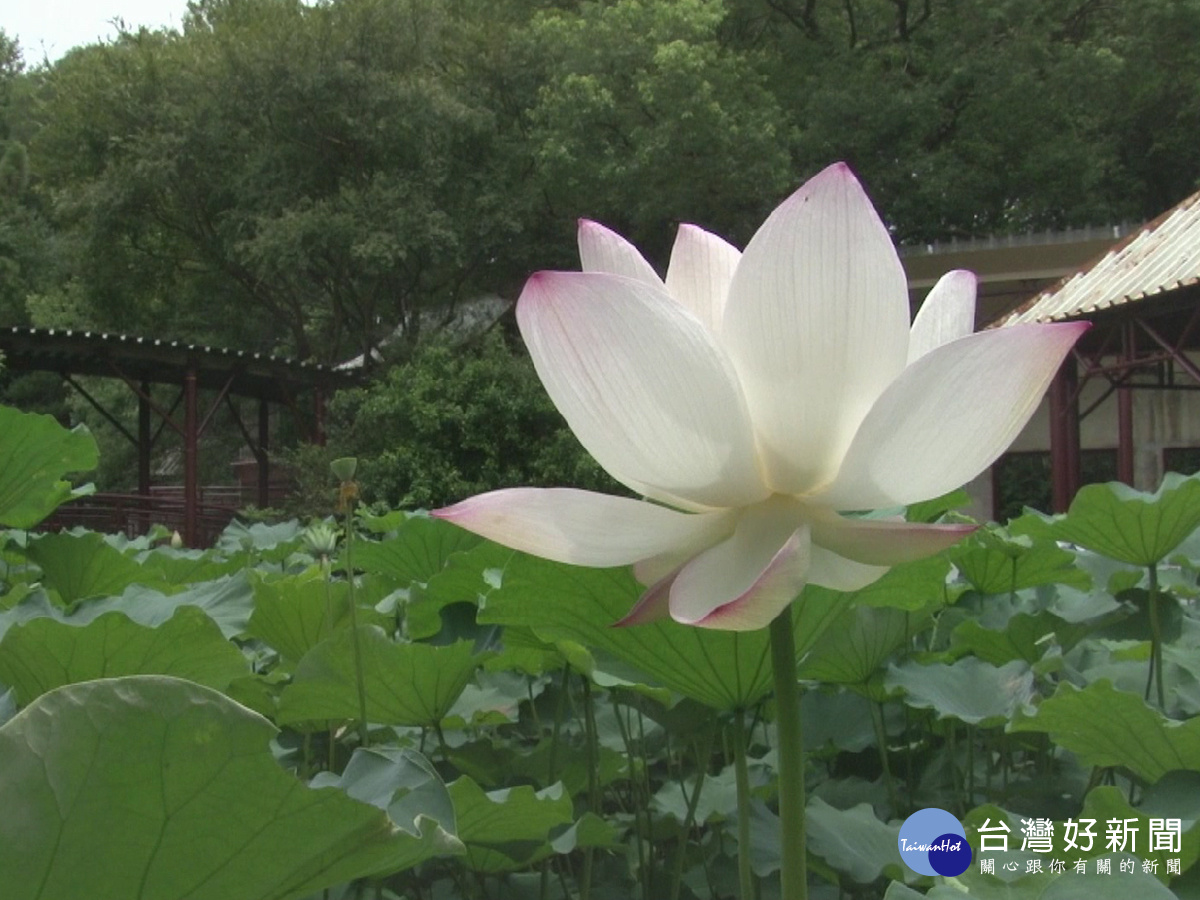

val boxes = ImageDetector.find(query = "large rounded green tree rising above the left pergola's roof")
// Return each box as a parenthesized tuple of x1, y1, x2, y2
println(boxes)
(29, 0, 525, 361)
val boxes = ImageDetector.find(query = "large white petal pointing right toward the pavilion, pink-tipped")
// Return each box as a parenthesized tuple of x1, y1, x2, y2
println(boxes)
(814, 322, 1088, 510)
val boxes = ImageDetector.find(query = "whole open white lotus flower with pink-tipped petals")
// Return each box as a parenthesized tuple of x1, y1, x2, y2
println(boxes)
(434, 164, 1087, 630)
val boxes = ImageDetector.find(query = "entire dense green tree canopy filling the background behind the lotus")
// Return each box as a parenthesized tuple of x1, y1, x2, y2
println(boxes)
(0, 0, 1200, 497)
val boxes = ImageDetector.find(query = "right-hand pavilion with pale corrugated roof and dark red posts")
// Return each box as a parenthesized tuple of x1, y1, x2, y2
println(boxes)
(1003, 193, 1200, 512)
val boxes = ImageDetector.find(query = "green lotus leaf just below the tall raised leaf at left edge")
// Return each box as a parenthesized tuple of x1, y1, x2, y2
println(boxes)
(28, 532, 167, 606)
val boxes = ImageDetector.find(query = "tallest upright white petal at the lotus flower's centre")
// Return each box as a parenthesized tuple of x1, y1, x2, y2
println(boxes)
(721, 164, 908, 494)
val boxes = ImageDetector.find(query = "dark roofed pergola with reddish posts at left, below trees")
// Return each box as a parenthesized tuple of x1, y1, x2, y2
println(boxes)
(0, 328, 356, 546)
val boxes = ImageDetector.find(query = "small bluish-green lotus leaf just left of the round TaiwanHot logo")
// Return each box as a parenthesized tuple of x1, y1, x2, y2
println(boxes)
(806, 797, 916, 884)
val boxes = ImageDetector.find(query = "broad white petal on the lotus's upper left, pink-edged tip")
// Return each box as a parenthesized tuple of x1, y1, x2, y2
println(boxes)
(517, 272, 769, 509)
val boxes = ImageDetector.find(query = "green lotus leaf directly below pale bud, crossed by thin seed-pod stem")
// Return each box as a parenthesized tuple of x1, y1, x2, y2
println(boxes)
(246, 569, 388, 662)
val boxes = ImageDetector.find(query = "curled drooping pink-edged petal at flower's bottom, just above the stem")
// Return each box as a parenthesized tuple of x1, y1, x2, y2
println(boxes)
(671, 498, 811, 631)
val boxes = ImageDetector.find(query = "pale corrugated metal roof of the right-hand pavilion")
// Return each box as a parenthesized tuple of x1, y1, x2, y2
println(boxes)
(1003, 193, 1200, 325)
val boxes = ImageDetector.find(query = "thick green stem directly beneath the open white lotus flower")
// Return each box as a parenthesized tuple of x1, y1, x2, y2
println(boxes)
(770, 608, 809, 900)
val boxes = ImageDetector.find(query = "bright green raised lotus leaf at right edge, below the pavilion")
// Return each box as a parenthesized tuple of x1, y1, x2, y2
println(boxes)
(1052, 472, 1200, 565)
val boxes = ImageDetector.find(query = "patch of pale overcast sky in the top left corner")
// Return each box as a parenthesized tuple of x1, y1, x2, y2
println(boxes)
(0, 0, 187, 66)
